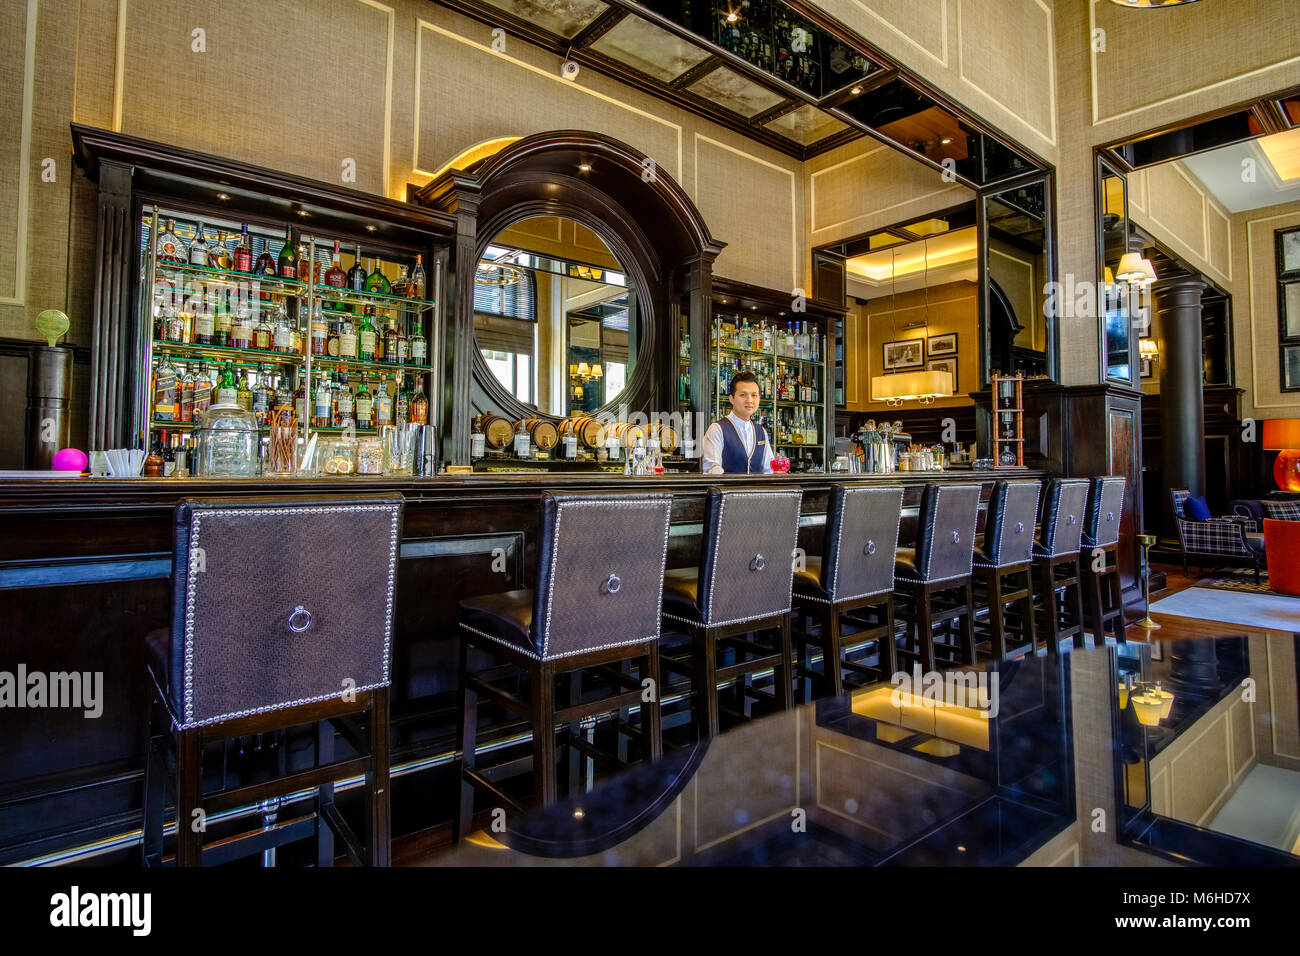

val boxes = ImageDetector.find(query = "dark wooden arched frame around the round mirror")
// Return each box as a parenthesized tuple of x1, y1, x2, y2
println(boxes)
(415, 130, 724, 463)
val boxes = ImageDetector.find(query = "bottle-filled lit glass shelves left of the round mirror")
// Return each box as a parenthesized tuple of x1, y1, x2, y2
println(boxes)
(139, 207, 438, 463)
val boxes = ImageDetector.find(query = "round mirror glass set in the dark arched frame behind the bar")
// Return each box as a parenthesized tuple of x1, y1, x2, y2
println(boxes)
(475, 216, 644, 418)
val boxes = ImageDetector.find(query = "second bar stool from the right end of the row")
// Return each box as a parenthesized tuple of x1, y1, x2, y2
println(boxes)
(1034, 479, 1088, 654)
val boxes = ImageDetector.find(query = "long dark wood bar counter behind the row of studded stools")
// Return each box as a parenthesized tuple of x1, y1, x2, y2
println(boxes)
(0, 471, 1047, 864)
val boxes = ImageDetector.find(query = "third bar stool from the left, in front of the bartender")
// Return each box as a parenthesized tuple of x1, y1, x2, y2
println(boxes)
(663, 486, 803, 739)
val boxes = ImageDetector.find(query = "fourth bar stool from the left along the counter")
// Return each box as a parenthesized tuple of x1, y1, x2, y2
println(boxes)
(794, 484, 902, 701)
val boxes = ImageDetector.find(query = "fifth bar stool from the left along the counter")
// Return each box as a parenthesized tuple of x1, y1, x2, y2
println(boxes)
(894, 481, 980, 671)
